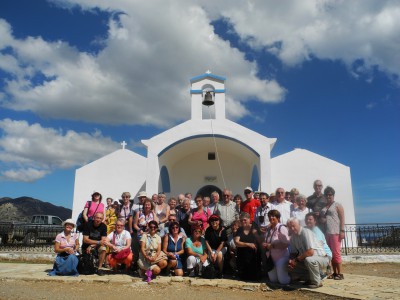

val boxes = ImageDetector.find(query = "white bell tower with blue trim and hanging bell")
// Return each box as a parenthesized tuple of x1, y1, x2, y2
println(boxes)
(190, 71, 225, 120)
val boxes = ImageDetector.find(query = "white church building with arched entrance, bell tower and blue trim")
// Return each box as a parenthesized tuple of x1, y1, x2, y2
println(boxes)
(72, 72, 355, 224)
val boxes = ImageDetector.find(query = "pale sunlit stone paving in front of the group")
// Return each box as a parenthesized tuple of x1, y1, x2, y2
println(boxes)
(0, 263, 400, 299)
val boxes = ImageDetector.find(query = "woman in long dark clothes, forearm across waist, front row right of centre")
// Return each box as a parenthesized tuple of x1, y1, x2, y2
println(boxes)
(234, 212, 260, 280)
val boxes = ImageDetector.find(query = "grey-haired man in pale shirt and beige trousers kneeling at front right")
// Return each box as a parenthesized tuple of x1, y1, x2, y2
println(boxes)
(287, 218, 329, 288)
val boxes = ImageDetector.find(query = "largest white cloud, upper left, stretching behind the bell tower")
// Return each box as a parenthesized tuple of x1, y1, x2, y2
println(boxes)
(0, 0, 286, 126)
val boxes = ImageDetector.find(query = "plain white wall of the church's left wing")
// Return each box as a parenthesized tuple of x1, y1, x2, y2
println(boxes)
(72, 149, 146, 220)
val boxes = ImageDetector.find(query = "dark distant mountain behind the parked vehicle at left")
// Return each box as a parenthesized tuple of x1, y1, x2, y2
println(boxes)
(0, 197, 72, 222)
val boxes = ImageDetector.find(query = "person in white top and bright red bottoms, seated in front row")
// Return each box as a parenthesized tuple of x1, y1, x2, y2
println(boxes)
(106, 219, 133, 272)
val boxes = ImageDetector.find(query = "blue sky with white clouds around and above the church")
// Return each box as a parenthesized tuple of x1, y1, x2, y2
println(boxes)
(0, 0, 400, 223)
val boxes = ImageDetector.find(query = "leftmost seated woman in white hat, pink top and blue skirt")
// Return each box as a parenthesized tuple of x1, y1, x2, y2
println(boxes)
(48, 219, 79, 276)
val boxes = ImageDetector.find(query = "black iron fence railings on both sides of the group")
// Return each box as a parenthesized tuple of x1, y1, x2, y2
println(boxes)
(0, 223, 400, 255)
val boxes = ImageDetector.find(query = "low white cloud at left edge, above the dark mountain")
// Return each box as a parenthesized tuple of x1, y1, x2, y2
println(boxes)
(0, 119, 120, 181)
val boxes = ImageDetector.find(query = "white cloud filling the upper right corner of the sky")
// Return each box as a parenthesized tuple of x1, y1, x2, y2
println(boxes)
(202, 0, 400, 78)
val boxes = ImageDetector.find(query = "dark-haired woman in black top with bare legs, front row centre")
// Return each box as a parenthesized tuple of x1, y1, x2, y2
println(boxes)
(204, 215, 228, 278)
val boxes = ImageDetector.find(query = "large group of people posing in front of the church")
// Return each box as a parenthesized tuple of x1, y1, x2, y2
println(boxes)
(49, 180, 345, 288)
